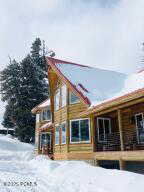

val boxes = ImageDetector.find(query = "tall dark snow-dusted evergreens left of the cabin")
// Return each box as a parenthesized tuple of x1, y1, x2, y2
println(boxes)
(0, 38, 48, 141)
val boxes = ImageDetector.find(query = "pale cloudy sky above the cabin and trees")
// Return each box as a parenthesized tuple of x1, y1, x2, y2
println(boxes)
(0, 0, 144, 119)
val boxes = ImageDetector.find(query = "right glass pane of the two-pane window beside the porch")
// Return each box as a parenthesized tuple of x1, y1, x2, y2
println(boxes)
(80, 119, 90, 141)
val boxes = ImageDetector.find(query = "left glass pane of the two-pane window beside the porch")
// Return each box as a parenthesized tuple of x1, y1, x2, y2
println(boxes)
(71, 121, 79, 142)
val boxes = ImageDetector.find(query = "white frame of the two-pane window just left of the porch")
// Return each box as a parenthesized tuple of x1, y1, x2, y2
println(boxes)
(70, 118, 91, 144)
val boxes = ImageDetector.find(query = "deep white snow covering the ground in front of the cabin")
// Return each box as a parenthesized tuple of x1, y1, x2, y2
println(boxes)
(0, 135, 144, 192)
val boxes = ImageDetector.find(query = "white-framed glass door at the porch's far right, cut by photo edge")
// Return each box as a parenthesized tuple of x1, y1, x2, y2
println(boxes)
(135, 113, 144, 144)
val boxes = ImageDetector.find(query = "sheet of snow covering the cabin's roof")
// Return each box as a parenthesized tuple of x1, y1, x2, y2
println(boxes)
(56, 63, 144, 106)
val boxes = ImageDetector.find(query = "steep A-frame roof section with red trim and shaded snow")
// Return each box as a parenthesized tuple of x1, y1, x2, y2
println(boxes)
(47, 57, 126, 105)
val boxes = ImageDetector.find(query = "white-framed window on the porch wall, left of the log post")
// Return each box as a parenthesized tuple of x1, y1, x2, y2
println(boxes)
(97, 118, 111, 142)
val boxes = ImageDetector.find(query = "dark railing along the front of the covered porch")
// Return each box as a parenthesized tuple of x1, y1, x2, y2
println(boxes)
(95, 130, 144, 151)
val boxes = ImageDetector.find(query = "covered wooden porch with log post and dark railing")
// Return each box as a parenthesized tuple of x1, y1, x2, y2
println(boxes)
(94, 103, 144, 152)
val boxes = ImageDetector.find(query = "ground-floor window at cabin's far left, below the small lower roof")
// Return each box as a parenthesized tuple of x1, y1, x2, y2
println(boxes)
(40, 133, 51, 149)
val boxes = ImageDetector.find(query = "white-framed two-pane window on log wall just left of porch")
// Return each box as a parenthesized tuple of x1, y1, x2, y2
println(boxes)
(70, 119, 90, 143)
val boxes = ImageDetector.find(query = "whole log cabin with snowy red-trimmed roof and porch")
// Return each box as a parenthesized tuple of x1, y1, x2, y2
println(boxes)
(32, 57, 144, 172)
